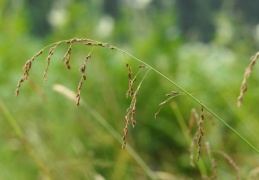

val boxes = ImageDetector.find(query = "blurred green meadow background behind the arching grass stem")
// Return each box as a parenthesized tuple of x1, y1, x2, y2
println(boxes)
(0, 0, 259, 180)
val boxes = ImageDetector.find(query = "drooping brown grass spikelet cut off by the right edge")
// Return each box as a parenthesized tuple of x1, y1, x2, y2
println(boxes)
(237, 52, 259, 107)
